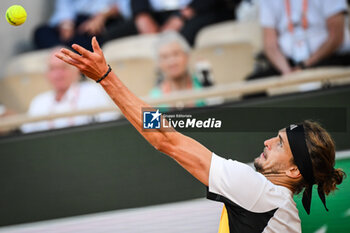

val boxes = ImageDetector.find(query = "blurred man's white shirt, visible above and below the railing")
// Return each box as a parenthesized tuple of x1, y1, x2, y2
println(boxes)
(21, 82, 120, 133)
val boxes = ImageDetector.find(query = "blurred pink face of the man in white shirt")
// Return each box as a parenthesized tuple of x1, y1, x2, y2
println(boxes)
(47, 53, 80, 92)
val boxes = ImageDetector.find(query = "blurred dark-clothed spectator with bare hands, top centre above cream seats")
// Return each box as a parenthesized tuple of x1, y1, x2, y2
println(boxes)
(106, 0, 234, 45)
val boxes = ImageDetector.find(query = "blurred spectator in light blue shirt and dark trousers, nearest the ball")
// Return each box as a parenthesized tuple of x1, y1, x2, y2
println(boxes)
(34, 0, 123, 50)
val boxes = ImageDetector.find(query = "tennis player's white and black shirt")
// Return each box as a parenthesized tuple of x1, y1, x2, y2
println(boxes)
(208, 153, 301, 233)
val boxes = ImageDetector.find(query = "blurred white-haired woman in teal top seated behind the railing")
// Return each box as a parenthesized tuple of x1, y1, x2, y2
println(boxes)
(150, 32, 204, 107)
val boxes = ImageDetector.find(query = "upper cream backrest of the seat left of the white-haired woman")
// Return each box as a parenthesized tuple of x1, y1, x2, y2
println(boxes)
(103, 35, 157, 61)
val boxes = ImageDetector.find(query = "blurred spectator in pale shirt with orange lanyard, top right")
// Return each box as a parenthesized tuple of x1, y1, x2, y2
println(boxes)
(248, 0, 350, 79)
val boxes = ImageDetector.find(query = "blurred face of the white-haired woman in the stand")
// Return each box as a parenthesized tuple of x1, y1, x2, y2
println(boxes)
(158, 42, 188, 79)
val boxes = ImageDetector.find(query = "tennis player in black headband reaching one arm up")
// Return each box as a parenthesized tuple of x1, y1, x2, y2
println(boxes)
(56, 37, 345, 233)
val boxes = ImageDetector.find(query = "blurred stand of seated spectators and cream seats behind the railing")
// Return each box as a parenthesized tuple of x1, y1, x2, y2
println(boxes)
(0, 0, 350, 136)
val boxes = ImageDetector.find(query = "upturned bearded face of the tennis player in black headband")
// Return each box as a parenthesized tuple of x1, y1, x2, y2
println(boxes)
(254, 129, 294, 174)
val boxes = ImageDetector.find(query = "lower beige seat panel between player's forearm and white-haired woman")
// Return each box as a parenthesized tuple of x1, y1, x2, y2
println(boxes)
(109, 57, 156, 96)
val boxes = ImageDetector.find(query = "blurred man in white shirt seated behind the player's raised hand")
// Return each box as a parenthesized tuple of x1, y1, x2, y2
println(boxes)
(21, 48, 119, 133)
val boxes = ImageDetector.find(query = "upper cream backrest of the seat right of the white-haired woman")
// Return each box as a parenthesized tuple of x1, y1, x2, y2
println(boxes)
(195, 21, 262, 53)
